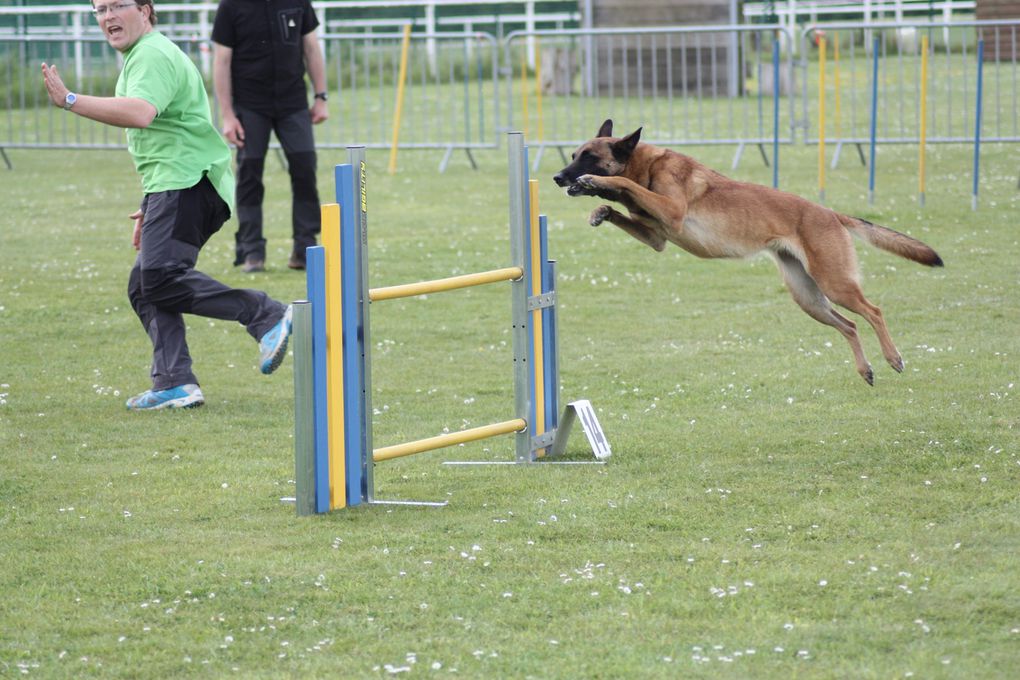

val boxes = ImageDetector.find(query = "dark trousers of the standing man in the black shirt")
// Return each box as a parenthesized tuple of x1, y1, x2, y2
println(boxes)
(234, 106, 320, 265)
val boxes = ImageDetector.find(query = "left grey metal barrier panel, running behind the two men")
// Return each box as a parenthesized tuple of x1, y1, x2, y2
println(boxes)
(0, 33, 500, 162)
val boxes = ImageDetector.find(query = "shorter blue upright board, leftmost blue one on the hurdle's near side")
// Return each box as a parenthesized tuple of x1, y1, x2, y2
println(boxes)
(306, 246, 329, 513)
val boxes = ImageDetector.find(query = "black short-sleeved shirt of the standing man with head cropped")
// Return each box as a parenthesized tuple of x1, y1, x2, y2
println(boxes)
(212, 0, 318, 115)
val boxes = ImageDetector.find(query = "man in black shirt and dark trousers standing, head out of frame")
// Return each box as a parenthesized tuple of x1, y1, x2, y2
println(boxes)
(212, 0, 328, 272)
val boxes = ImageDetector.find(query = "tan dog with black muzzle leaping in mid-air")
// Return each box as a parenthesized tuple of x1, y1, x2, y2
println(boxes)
(554, 120, 942, 384)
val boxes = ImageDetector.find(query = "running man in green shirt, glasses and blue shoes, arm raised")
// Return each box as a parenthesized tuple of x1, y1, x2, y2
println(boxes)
(43, 0, 291, 411)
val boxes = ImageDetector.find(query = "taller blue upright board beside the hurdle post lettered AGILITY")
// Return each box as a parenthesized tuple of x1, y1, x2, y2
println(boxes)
(335, 163, 363, 506)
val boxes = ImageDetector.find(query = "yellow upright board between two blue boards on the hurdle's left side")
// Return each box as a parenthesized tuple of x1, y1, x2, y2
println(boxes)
(321, 203, 347, 510)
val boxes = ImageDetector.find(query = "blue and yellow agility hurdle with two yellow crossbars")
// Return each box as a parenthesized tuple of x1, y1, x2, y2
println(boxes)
(294, 133, 610, 515)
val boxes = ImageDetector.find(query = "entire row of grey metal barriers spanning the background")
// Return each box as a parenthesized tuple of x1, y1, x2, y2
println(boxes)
(0, 20, 1020, 175)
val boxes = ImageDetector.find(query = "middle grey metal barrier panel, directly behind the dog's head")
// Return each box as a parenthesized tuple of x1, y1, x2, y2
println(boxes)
(503, 25, 795, 173)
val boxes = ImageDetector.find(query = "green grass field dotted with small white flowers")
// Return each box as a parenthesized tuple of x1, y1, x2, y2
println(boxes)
(0, 139, 1020, 679)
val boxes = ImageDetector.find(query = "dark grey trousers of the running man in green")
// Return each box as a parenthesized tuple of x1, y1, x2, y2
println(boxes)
(128, 177, 287, 390)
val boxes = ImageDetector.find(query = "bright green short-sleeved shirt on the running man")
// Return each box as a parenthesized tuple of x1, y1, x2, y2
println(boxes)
(116, 31, 234, 212)
